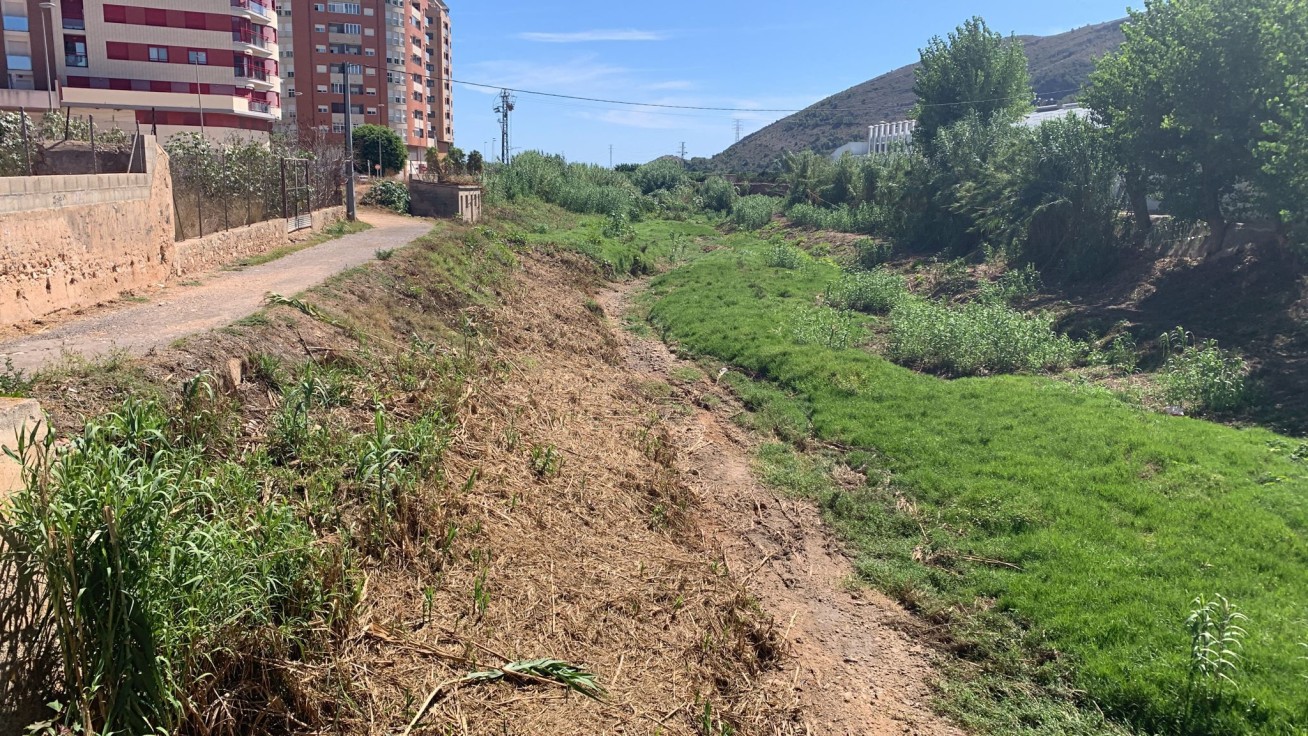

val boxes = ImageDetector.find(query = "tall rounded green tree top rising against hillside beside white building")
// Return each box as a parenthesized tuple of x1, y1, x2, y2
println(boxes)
(912, 17, 1033, 149)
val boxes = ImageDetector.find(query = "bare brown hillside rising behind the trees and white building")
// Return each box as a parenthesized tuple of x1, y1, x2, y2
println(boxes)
(709, 20, 1124, 173)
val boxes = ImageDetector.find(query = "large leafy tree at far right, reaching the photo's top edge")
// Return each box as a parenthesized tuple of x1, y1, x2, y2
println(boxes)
(1086, 0, 1281, 238)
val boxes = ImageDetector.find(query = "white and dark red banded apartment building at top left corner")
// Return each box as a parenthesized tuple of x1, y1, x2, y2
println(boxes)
(0, 0, 281, 140)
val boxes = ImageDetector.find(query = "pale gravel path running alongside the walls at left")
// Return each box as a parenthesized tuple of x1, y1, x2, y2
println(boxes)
(0, 210, 432, 371)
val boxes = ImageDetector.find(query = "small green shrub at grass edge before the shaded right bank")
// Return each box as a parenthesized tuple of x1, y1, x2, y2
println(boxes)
(1158, 327, 1249, 412)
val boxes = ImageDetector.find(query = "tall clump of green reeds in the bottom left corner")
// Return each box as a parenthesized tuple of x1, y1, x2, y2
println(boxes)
(3, 400, 336, 733)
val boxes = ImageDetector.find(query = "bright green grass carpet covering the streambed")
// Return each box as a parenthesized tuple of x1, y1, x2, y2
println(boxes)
(650, 237, 1308, 735)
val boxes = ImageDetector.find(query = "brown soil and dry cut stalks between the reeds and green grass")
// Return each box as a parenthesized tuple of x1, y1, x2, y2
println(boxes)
(0, 226, 961, 736)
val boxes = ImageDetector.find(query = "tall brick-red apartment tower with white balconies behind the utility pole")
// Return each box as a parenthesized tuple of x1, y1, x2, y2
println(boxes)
(280, 0, 454, 171)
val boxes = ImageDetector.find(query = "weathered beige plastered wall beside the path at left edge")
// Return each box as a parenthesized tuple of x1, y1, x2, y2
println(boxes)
(0, 139, 174, 324)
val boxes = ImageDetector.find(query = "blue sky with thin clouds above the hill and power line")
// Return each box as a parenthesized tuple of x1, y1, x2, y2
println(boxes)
(449, 0, 1124, 165)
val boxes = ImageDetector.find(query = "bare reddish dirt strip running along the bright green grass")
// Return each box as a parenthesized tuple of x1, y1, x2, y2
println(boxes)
(598, 282, 963, 736)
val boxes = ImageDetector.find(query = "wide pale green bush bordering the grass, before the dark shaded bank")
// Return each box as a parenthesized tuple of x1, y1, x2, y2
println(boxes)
(889, 298, 1084, 375)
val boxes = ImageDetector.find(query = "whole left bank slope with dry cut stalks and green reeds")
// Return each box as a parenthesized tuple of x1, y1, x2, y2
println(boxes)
(0, 213, 802, 735)
